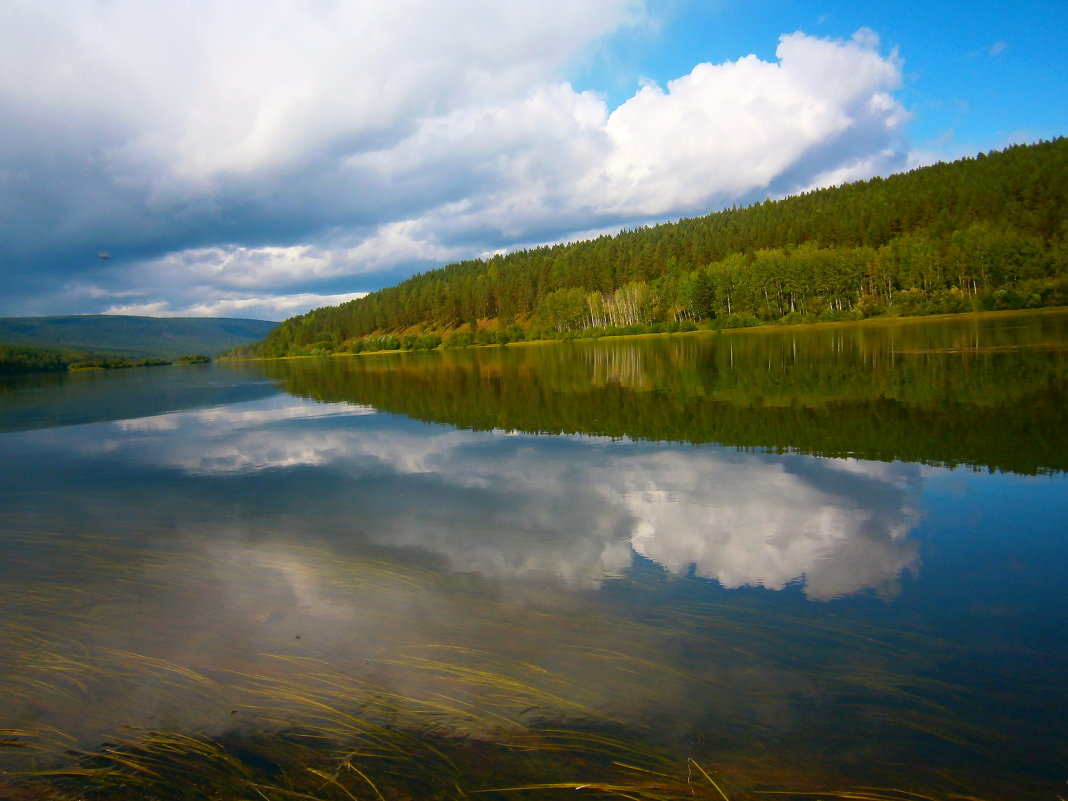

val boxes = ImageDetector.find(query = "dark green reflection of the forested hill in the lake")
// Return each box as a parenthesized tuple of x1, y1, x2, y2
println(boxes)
(258, 311, 1068, 473)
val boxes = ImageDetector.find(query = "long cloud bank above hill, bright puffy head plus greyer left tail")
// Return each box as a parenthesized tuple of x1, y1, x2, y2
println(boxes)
(337, 32, 908, 233)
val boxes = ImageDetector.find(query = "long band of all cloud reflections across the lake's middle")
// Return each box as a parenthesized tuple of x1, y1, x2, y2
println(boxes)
(14, 395, 920, 600)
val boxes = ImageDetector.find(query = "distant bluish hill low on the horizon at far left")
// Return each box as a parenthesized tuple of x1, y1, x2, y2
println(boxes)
(0, 314, 278, 359)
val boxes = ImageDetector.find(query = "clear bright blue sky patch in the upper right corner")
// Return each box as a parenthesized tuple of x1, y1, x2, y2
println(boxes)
(572, 0, 1068, 152)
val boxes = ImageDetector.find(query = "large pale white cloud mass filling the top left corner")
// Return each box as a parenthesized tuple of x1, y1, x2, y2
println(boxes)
(0, 0, 629, 186)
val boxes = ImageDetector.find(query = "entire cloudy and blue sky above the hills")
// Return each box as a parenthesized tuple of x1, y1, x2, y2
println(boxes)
(0, 0, 1068, 320)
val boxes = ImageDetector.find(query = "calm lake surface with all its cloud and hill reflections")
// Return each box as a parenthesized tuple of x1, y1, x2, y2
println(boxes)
(0, 313, 1068, 801)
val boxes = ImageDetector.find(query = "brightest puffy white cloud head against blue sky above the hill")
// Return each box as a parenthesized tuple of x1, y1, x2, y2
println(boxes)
(587, 31, 906, 215)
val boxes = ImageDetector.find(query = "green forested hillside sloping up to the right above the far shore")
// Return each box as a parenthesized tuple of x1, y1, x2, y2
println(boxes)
(239, 138, 1068, 357)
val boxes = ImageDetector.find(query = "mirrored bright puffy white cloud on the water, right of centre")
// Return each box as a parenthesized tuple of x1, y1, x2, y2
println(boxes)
(624, 453, 920, 600)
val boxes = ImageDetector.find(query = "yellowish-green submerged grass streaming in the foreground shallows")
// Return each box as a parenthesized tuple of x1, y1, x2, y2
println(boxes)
(0, 539, 1016, 801)
